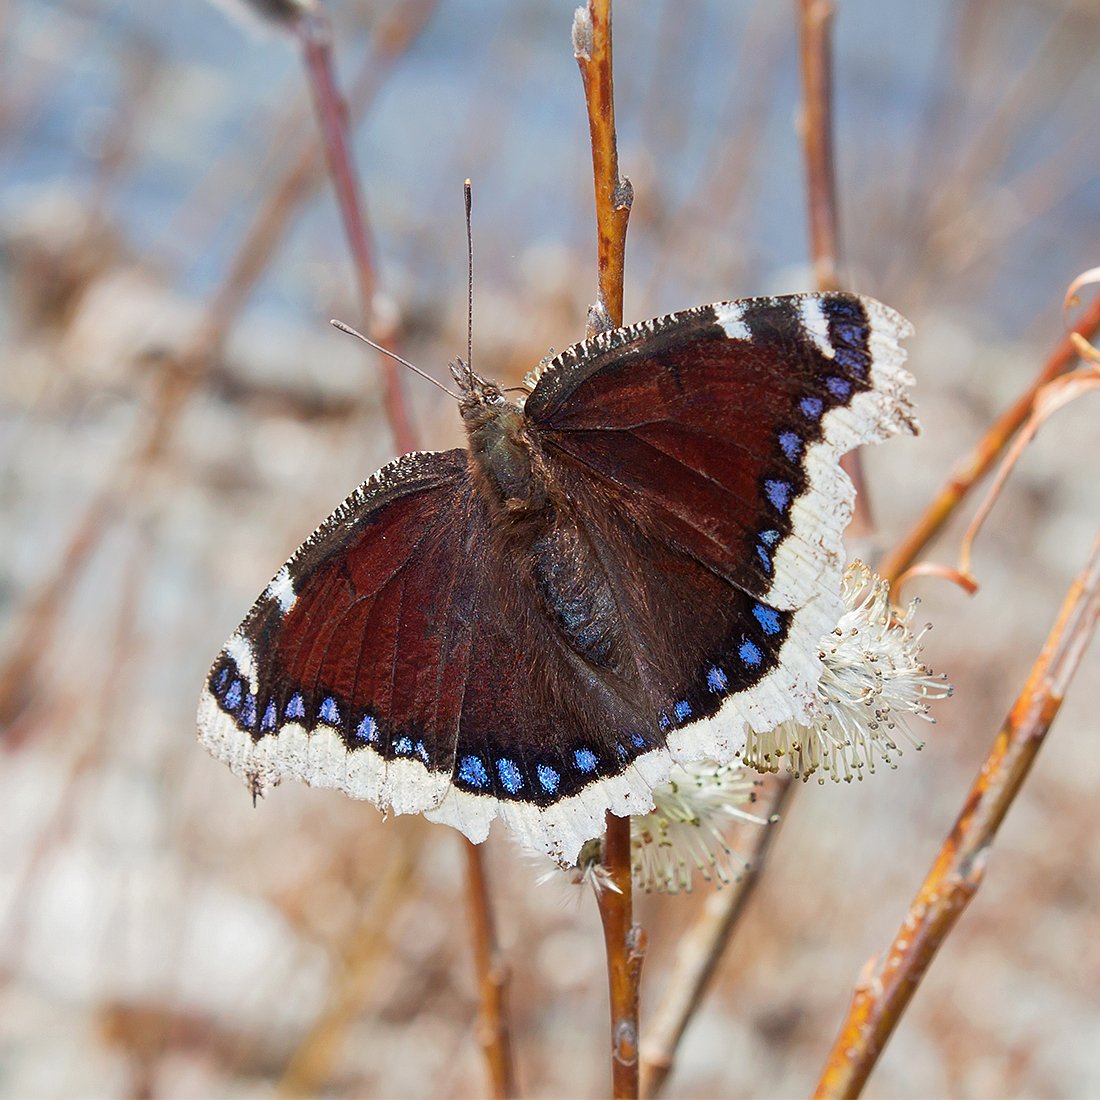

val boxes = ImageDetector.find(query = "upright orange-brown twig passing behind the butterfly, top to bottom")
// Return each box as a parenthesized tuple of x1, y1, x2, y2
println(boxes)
(573, 0, 645, 1100)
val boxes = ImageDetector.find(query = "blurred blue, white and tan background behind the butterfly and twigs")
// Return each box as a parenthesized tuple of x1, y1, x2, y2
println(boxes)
(0, 0, 1100, 1098)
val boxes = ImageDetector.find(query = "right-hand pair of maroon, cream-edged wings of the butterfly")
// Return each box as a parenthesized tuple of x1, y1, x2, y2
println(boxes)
(526, 294, 914, 759)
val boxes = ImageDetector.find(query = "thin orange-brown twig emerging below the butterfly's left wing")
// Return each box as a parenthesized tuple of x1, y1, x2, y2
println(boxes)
(461, 837, 519, 1100)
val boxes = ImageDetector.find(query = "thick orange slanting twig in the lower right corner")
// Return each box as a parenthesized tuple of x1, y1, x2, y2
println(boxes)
(814, 538, 1100, 1098)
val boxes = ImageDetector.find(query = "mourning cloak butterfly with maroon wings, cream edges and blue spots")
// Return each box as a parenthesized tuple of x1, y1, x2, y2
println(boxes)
(198, 294, 916, 860)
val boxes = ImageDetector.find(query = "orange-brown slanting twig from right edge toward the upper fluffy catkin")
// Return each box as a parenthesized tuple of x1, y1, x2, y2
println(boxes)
(878, 288, 1100, 584)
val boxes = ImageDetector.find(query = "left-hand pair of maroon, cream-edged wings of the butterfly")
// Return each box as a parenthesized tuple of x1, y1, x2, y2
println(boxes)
(198, 451, 668, 859)
